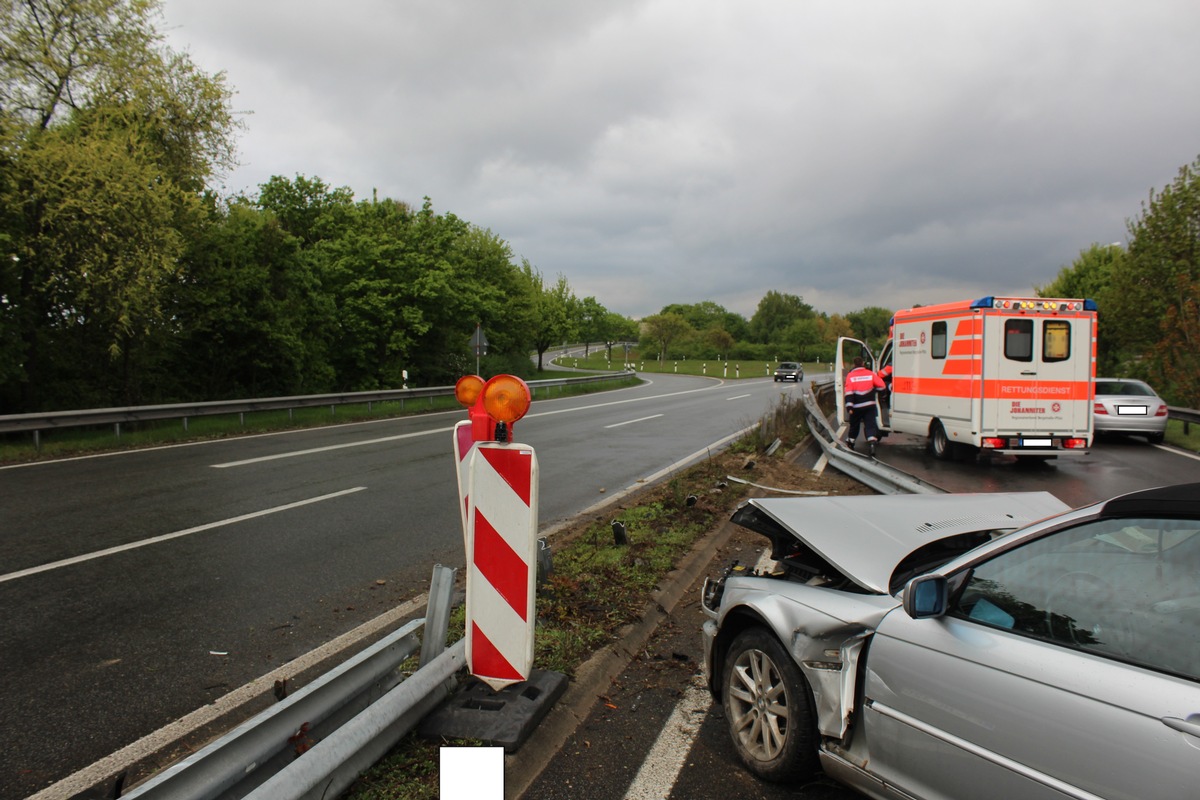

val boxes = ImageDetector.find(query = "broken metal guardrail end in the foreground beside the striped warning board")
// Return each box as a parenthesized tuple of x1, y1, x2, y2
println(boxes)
(122, 566, 466, 800)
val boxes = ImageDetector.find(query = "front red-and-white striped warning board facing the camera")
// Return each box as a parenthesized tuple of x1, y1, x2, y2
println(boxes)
(467, 441, 538, 691)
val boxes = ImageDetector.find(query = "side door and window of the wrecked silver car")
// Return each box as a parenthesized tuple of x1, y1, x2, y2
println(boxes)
(863, 521, 1200, 800)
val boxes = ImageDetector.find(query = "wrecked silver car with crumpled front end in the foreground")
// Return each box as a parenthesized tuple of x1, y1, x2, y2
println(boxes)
(702, 483, 1200, 800)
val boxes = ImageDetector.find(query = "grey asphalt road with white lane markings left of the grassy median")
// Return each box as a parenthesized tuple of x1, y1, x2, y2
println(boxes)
(0, 375, 793, 799)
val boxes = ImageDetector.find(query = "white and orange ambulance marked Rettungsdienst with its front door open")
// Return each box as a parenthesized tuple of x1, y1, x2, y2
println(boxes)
(834, 297, 1096, 461)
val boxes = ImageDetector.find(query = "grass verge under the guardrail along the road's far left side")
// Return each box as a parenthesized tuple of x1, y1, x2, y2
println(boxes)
(0, 372, 638, 463)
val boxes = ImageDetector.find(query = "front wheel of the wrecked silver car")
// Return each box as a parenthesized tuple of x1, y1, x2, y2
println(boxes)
(721, 627, 820, 781)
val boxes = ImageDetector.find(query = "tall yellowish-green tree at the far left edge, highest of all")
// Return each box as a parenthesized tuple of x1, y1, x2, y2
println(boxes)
(0, 0, 236, 410)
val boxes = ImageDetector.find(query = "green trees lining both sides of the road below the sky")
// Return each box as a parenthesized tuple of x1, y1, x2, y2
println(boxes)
(0, 0, 1200, 414)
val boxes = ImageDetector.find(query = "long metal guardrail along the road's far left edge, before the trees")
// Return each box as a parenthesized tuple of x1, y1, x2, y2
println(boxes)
(0, 371, 636, 434)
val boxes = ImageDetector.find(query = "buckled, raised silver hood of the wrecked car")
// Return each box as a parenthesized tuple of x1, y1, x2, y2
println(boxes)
(732, 492, 1070, 594)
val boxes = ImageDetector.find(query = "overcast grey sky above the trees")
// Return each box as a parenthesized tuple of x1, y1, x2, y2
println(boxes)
(162, 0, 1200, 318)
